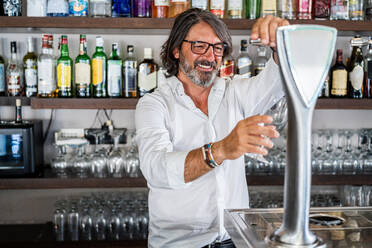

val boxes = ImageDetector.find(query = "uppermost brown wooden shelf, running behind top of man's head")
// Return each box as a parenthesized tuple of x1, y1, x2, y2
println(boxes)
(0, 16, 372, 31)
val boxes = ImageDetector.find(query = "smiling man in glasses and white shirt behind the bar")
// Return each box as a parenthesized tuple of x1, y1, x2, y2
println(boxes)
(135, 9, 288, 248)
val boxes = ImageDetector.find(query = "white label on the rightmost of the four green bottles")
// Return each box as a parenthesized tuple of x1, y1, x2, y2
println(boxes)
(107, 60, 122, 96)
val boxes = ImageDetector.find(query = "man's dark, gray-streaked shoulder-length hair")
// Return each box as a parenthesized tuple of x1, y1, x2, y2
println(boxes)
(160, 8, 232, 77)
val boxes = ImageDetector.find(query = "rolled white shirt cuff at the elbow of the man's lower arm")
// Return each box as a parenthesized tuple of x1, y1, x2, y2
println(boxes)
(165, 152, 189, 187)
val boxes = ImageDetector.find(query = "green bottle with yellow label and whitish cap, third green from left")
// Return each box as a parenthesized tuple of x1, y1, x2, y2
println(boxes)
(92, 36, 107, 97)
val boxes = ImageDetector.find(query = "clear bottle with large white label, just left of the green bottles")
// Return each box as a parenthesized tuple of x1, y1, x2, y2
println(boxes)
(37, 34, 56, 97)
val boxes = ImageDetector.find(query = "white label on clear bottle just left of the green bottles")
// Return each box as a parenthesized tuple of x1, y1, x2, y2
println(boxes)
(37, 60, 56, 94)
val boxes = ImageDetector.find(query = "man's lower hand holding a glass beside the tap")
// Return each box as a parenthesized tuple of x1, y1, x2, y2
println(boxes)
(212, 115, 279, 164)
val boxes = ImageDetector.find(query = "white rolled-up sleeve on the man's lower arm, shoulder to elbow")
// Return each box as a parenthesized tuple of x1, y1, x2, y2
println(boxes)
(135, 95, 189, 188)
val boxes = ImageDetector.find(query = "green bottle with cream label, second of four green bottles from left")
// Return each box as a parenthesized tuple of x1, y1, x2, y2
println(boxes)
(75, 34, 92, 97)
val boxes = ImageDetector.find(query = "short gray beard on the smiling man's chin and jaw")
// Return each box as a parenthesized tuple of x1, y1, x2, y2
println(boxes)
(179, 53, 217, 88)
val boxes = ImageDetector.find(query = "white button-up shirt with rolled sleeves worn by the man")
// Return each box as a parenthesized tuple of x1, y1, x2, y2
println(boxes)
(135, 59, 283, 248)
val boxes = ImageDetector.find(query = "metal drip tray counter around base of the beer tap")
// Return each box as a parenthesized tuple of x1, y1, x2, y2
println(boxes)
(225, 207, 372, 248)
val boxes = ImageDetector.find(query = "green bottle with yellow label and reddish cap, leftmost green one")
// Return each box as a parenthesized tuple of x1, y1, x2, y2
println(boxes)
(57, 35, 73, 97)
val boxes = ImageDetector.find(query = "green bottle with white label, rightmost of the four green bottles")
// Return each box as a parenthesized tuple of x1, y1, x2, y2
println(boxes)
(107, 43, 123, 97)
